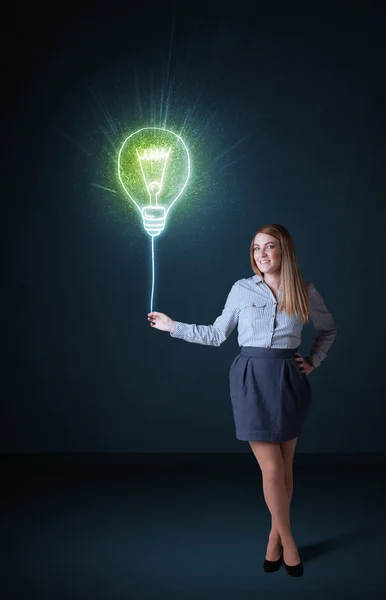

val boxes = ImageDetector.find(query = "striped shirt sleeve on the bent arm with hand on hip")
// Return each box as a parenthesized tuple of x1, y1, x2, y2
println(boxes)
(306, 283, 338, 368)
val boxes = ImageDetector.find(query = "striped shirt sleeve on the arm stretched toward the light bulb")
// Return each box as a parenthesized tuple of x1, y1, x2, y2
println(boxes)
(170, 283, 240, 346)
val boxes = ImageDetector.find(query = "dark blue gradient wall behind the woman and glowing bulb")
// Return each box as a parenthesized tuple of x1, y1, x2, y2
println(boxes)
(0, 1, 386, 454)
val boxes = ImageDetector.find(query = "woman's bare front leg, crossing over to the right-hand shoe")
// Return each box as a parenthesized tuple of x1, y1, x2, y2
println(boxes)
(249, 441, 300, 566)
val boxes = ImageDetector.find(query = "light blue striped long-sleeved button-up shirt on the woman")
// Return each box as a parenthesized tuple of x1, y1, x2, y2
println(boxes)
(170, 275, 337, 367)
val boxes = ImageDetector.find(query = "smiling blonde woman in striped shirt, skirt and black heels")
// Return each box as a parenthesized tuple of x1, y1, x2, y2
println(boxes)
(148, 225, 337, 576)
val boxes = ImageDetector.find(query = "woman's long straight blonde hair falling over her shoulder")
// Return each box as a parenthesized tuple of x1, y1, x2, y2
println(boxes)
(250, 224, 310, 324)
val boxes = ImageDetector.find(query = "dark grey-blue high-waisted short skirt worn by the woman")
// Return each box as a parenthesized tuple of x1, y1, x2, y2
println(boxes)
(229, 346, 312, 442)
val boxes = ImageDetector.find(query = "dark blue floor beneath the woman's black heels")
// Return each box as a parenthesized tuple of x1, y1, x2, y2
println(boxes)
(0, 462, 386, 600)
